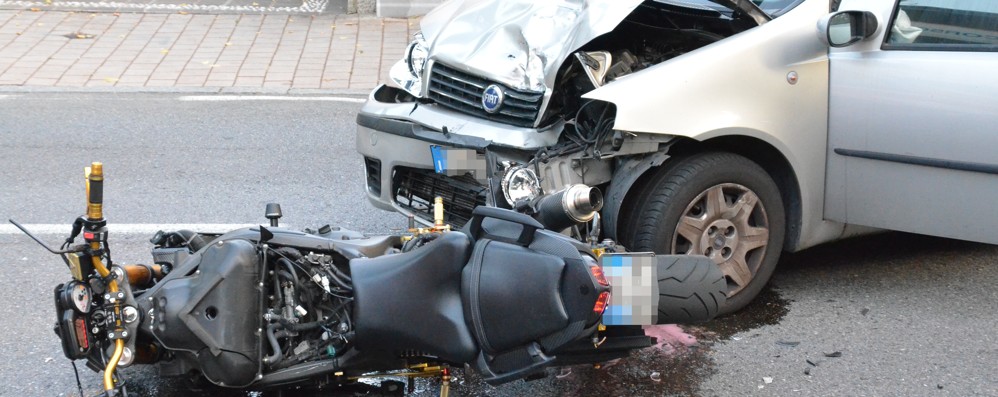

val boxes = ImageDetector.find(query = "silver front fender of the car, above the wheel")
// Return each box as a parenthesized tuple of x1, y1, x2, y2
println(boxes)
(585, 0, 844, 250)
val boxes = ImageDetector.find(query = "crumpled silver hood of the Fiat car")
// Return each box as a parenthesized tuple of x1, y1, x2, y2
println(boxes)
(421, 0, 642, 92)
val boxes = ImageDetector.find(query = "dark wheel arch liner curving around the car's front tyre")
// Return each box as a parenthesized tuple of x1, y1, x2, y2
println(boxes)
(604, 135, 803, 250)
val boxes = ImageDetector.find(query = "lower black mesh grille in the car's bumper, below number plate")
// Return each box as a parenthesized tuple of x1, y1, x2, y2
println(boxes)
(392, 167, 485, 228)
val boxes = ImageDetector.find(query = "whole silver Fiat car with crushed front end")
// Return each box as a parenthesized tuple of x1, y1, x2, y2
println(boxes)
(357, 0, 998, 312)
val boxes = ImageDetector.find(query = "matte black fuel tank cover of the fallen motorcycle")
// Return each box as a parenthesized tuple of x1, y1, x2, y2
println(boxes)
(151, 240, 261, 386)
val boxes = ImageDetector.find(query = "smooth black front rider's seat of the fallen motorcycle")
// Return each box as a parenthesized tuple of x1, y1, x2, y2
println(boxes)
(350, 232, 478, 363)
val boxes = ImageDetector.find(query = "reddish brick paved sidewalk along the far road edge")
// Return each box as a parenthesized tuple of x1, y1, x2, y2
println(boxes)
(0, 11, 418, 92)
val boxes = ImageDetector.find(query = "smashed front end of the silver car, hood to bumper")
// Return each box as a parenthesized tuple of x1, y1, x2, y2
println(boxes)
(357, 0, 769, 225)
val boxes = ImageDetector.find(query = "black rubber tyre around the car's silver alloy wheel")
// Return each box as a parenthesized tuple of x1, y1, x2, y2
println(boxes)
(621, 152, 786, 315)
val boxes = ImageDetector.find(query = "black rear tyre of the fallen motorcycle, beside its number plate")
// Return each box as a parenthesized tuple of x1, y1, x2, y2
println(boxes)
(656, 255, 728, 324)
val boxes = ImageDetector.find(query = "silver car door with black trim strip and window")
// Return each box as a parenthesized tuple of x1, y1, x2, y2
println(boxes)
(825, 0, 998, 243)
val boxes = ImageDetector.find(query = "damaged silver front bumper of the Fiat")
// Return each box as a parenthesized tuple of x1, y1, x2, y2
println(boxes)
(356, 86, 564, 225)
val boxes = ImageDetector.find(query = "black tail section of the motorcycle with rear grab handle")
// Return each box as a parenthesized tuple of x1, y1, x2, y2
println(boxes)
(462, 209, 598, 385)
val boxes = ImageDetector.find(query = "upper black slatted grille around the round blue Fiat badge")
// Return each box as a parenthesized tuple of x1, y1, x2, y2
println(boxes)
(429, 63, 544, 127)
